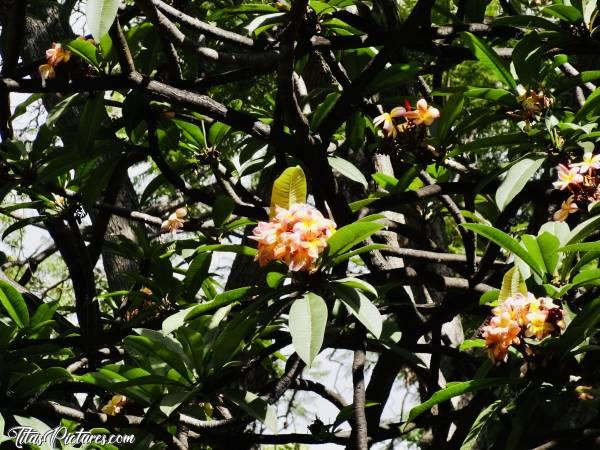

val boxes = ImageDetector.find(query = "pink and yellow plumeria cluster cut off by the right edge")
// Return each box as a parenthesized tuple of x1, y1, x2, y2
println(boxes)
(552, 152, 600, 222)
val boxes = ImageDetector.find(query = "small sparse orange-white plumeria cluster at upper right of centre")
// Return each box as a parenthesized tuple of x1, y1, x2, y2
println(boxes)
(373, 98, 440, 139)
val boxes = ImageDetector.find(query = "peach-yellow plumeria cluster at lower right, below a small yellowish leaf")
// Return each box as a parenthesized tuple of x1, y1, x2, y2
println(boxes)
(481, 292, 565, 364)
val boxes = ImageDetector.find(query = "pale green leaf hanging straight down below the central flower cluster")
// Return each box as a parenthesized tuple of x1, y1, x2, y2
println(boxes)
(288, 292, 327, 367)
